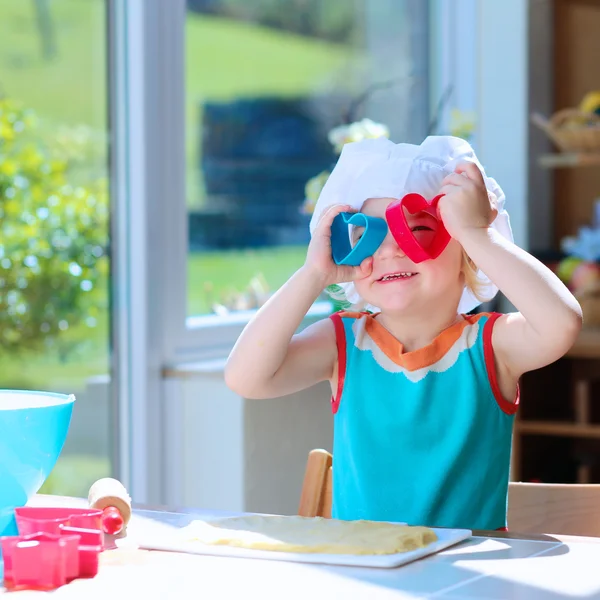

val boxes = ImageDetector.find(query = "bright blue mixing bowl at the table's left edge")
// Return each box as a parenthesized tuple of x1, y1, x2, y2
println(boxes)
(0, 390, 75, 536)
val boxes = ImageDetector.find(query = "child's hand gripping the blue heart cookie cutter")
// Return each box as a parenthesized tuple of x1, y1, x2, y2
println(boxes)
(304, 205, 373, 288)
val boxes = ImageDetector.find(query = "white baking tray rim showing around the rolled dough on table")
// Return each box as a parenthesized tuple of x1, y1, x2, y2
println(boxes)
(136, 527, 472, 569)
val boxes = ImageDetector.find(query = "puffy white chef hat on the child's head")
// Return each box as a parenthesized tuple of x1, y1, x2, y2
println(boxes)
(310, 136, 513, 313)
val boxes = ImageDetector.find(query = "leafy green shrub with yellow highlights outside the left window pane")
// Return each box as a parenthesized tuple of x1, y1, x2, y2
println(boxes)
(0, 98, 108, 354)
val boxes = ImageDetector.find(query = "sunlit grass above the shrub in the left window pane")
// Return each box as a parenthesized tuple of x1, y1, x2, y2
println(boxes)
(0, 0, 108, 131)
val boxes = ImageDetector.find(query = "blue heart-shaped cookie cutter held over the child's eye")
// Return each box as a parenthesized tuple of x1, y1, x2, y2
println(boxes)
(331, 212, 388, 267)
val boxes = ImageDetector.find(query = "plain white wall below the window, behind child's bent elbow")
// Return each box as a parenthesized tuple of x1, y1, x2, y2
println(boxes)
(165, 370, 333, 514)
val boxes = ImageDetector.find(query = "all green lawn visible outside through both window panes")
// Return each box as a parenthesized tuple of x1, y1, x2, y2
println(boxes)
(0, 0, 352, 494)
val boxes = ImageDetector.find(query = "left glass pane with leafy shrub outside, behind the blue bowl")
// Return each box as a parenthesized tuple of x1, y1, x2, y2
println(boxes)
(0, 0, 111, 496)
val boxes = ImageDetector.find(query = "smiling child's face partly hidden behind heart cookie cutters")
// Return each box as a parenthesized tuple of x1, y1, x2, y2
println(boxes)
(352, 198, 464, 313)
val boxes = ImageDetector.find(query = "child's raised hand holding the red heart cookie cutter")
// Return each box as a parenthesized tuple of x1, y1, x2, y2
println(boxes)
(439, 163, 498, 242)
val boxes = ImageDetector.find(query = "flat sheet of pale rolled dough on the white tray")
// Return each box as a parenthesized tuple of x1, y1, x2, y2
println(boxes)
(181, 515, 438, 555)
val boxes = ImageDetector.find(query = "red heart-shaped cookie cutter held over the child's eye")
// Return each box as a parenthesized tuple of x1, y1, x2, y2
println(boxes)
(385, 193, 450, 263)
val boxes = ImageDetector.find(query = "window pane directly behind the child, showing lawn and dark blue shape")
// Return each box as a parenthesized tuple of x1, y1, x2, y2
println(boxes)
(185, 0, 429, 322)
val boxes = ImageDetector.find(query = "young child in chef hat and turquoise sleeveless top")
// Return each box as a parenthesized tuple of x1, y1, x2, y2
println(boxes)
(225, 137, 582, 529)
